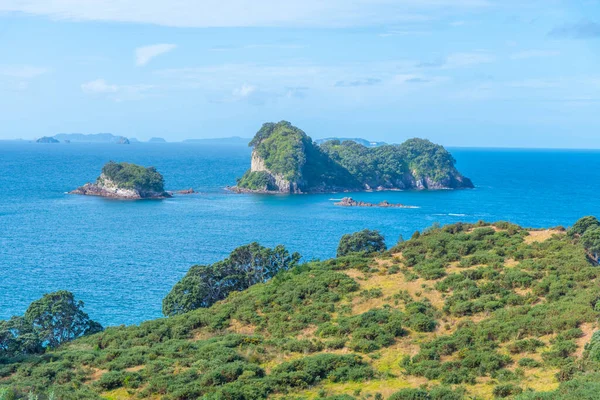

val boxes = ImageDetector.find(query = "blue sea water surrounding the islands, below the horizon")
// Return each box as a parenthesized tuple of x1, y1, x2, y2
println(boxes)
(0, 142, 600, 325)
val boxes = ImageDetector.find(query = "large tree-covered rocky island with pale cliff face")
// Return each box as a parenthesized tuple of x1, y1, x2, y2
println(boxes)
(228, 121, 473, 193)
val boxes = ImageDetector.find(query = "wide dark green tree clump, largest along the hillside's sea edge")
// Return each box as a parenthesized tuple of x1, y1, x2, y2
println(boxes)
(163, 242, 301, 316)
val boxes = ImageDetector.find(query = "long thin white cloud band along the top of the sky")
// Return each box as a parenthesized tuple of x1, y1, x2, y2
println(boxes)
(0, 0, 495, 27)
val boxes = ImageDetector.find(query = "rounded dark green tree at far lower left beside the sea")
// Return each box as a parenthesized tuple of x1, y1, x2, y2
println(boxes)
(24, 290, 102, 347)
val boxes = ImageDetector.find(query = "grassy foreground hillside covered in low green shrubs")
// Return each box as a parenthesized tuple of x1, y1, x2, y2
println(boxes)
(0, 220, 600, 400)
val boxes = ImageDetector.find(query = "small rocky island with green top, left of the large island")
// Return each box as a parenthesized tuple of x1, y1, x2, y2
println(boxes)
(70, 161, 171, 200)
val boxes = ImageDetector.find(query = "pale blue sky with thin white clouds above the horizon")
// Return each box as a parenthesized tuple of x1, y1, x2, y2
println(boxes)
(0, 0, 600, 148)
